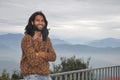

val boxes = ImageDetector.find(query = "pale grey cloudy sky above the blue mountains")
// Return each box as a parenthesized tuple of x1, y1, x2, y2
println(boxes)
(0, 0, 120, 43)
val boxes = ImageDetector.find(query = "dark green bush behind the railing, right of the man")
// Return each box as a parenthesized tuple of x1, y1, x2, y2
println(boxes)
(51, 56, 91, 73)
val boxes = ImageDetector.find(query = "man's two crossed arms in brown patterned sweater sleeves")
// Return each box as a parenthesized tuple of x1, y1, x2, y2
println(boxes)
(21, 36, 56, 66)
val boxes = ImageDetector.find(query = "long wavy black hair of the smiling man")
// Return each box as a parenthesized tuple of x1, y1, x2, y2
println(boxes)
(24, 11, 49, 41)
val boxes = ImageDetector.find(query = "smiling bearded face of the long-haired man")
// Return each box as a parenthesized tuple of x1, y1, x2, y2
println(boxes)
(32, 15, 45, 30)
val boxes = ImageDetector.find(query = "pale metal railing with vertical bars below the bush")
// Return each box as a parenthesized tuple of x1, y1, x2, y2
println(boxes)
(50, 66, 120, 80)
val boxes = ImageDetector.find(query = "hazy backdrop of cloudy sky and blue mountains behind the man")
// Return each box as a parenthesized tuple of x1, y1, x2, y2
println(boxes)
(0, 0, 120, 77)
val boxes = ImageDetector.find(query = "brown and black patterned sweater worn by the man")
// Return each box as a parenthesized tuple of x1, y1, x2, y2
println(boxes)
(20, 34, 56, 76)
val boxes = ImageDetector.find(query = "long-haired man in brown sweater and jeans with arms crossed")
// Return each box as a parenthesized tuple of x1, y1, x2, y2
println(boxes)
(20, 11, 56, 80)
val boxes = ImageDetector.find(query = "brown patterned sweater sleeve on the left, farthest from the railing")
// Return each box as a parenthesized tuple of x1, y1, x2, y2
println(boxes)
(21, 36, 44, 66)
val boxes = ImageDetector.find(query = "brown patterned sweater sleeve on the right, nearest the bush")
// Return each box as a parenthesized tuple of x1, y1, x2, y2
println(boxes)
(45, 37, 56, 61)
